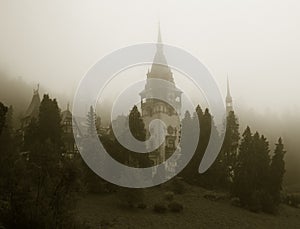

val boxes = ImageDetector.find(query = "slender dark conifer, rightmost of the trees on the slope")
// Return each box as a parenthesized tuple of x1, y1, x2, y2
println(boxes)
(269, 138, 286, 204)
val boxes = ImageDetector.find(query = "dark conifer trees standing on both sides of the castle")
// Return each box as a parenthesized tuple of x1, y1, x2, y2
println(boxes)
(0, 95, 286, 228)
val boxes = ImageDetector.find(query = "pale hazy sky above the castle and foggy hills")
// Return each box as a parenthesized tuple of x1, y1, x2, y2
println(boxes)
(0, 0, 300, 112)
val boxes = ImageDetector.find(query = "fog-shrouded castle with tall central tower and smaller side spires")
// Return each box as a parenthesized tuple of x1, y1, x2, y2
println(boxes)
(21, 28, 233, 170)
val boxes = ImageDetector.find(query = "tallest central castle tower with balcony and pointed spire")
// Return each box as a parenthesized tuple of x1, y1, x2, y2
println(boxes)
(140, 25, 182, 173)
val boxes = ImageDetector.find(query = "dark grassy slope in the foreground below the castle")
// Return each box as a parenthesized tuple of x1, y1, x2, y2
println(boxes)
(78, 186, 300, 229)
